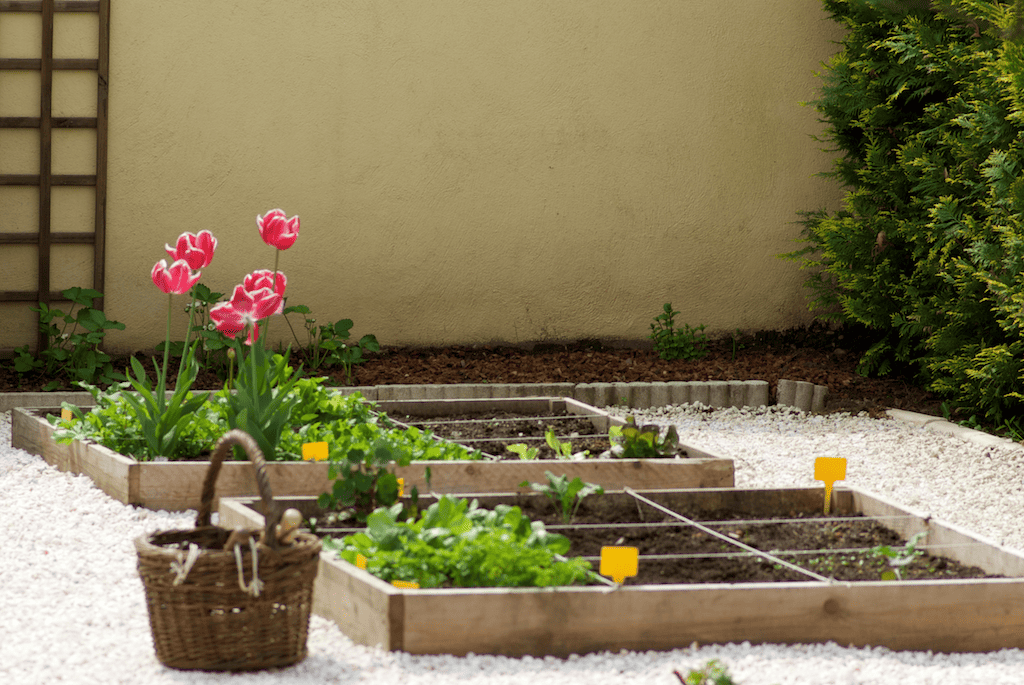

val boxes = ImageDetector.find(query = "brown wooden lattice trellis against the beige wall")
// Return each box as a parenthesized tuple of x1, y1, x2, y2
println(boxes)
(0, 0, 110, 349)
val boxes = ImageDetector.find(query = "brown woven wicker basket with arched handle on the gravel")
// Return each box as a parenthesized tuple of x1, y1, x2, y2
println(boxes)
(135, 430, 321, 671)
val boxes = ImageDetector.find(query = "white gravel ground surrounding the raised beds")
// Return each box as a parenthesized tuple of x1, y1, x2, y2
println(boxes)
(6, 408, 1024, 685)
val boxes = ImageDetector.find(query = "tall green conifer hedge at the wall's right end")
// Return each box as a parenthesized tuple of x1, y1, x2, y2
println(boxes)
(784, 0, 1024, 424)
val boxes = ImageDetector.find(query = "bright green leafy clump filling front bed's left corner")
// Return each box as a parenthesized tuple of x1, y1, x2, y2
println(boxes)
(324, 496, 591, 588)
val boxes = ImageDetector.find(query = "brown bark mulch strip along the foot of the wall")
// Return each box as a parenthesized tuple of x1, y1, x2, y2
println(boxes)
(0, 325, 941, 416)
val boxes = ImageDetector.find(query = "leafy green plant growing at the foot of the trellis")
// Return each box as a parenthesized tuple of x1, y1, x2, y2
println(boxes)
(14, 288, 125, 390)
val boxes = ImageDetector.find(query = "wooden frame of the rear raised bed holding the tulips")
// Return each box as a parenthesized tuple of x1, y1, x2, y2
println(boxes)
(11, 397, 735, 511)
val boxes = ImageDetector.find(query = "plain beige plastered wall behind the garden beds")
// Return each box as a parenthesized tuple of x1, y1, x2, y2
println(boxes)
(0, 0, 840, 349)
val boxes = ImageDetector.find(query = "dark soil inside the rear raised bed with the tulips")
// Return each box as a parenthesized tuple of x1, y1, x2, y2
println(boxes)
(391, 405, 611, 461)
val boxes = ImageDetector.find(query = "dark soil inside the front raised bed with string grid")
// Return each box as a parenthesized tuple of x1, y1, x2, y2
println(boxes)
(319, 496, 989, 585)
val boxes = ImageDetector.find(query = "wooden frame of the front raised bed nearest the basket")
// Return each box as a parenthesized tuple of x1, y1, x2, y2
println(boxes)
(220, 487, 1024, 656)
